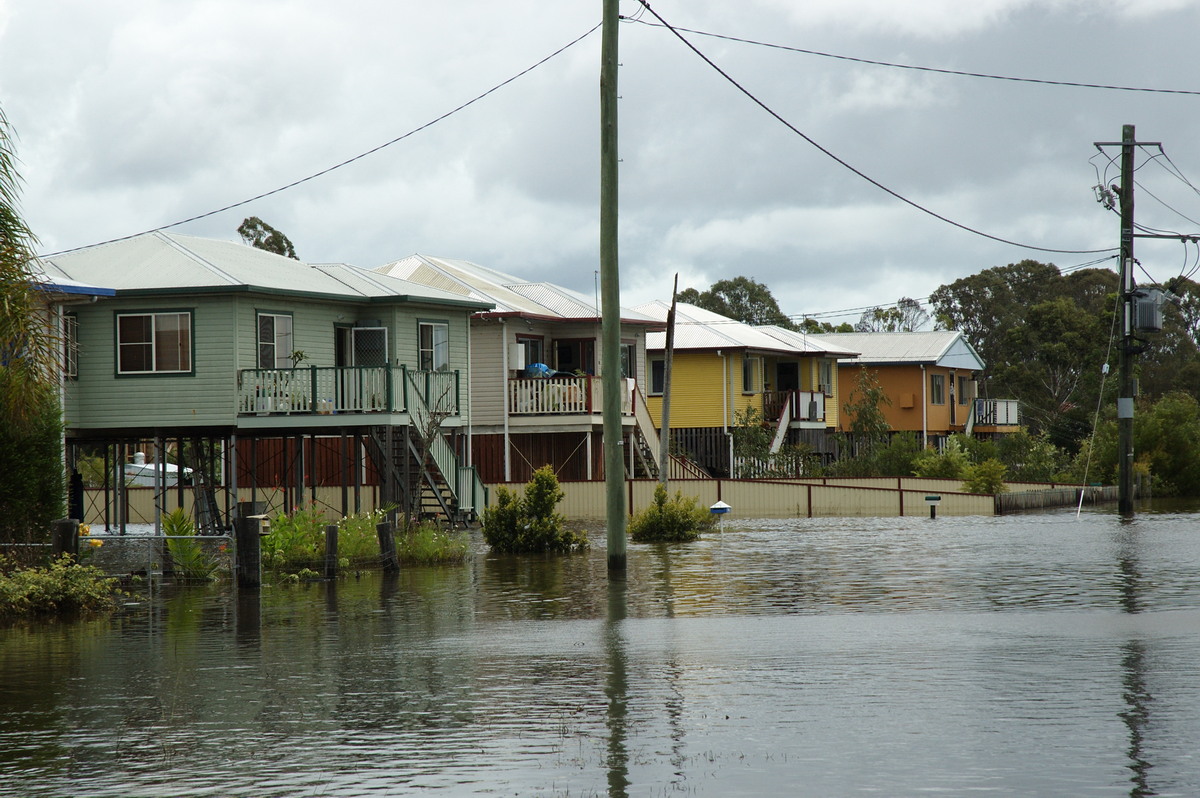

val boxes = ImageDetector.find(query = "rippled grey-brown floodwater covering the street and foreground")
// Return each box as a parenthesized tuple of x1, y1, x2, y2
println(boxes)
(0, 509, 1200, 798)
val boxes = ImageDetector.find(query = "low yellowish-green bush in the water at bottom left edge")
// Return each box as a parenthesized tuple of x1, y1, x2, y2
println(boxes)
(0, 554, 124, 622)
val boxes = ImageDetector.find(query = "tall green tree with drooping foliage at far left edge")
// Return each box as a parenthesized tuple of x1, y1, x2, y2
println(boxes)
(0, 105, 64, 542)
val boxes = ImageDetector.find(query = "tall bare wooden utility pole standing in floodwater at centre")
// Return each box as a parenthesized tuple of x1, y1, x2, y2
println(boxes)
(600, 0, 625, 577)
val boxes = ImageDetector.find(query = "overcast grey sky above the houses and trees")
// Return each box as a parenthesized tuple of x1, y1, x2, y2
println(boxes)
(0, 0, 1200, 322)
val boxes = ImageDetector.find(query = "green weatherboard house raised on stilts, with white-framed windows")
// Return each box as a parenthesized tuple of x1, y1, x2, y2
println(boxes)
(41, 233, 491, 526)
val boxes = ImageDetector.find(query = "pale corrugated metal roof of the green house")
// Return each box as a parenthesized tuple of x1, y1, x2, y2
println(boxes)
(43, 232, 488, 308)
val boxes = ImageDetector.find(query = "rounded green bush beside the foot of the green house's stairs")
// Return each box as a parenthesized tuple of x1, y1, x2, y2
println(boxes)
(482, 466, 588, 553)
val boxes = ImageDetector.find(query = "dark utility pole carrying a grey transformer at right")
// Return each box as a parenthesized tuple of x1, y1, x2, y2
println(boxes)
(1117, 125, 1138, 516)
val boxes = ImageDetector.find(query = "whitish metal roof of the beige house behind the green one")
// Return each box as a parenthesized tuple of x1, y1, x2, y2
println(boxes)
(374, 254, 654, 324)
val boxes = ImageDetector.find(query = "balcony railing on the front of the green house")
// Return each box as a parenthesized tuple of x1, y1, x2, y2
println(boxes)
(238, 366, 458, 415)
